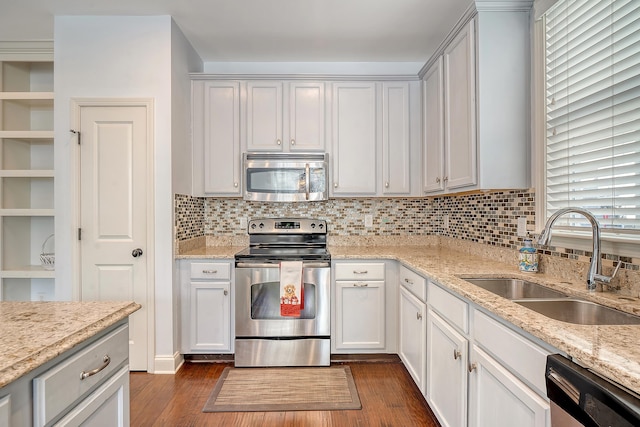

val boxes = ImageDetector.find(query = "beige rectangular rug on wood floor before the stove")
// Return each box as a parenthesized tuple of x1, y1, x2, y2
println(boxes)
(202, 366, 362, 412)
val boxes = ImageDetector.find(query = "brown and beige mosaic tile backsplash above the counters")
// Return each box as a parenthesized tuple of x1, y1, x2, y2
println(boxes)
(175, 190, 640, 271)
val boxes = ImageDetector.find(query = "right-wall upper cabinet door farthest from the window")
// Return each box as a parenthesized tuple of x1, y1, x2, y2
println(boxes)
(422, 57, 444, 193)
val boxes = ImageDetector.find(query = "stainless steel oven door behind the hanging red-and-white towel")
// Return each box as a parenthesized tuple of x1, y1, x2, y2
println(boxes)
(235, 263, 331, 339)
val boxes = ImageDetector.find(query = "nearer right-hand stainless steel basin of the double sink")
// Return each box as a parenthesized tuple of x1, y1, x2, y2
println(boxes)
(514, 298, 640, 325)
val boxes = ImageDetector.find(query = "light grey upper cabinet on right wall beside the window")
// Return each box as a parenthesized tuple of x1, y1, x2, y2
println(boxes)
(422, 5, 530, 194)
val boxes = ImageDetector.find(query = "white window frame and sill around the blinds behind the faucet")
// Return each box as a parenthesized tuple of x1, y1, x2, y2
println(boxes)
(531, 0, 640, 258)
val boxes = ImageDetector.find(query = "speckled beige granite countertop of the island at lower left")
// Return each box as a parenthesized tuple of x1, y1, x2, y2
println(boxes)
(0, 301, 140, 388)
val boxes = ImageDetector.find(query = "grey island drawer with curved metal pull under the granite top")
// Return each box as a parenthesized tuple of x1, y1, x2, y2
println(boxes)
(33, 325, 129, 425)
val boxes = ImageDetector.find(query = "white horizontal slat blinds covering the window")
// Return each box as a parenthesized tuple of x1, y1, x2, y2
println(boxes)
(545, 0, 640, 234)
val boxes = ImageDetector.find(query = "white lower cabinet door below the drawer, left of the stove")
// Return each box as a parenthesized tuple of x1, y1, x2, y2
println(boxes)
(189, 282, 231, 352)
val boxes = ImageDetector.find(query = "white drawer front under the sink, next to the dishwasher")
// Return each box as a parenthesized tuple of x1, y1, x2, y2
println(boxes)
(473, 310, 550, 396)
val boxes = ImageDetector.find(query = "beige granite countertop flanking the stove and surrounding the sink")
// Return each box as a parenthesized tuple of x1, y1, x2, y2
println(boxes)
(177, 245, 640, 393)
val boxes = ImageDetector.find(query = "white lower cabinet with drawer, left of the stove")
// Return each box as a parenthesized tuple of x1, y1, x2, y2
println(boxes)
(181, 260, 233, 354)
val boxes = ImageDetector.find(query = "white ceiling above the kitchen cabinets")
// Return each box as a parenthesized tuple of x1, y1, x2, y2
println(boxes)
(0, 0, 471, 62)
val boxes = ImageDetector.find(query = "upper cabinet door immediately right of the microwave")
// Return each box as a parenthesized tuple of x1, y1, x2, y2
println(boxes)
(332, 83, 378, 196)
